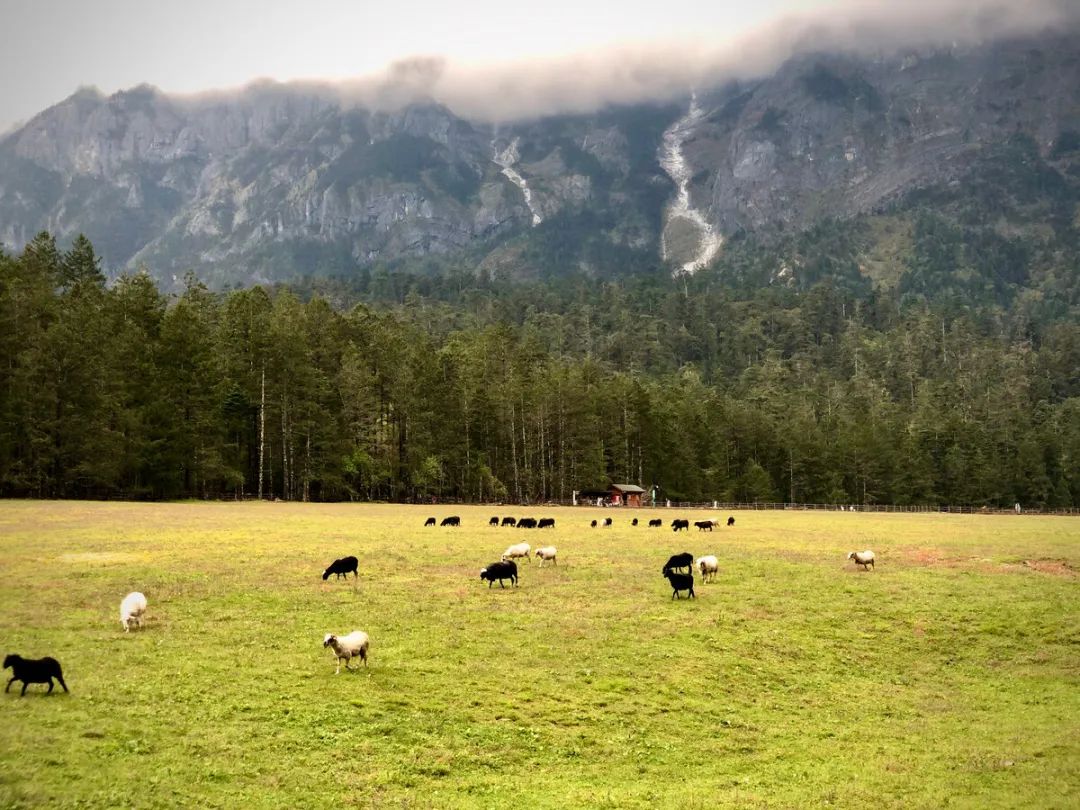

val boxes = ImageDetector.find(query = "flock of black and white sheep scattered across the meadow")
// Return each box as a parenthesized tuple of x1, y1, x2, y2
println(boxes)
(3, 515, 874, 694)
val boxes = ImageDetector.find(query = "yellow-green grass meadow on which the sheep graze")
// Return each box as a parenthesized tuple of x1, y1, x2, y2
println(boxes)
(0, 502, 1080, 808)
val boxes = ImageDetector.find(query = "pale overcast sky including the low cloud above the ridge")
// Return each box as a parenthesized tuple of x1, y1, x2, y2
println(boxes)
(0, 0, 1080, 132)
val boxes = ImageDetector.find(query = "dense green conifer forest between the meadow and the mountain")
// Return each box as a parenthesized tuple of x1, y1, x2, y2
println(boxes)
(0, 233, 1080, 508)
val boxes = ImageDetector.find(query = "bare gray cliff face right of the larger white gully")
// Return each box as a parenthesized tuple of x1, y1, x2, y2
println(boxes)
(688, 38, 1080, 233)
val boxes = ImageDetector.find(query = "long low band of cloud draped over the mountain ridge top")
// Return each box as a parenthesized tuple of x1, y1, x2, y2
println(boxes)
(177, 0, 1080, 122)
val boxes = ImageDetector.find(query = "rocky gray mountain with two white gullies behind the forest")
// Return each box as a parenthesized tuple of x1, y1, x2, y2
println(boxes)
(0, 32, 1080, 286)
